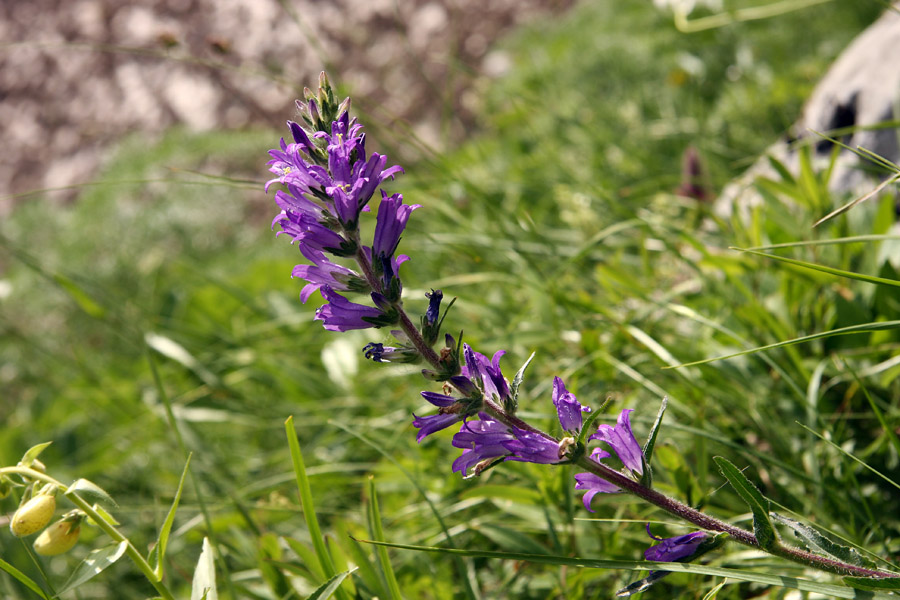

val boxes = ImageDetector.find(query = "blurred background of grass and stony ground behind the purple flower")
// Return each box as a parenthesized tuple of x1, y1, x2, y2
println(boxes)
(0, 0, 900, 599)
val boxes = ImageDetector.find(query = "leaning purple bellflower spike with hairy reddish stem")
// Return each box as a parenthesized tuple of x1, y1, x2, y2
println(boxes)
(267, 73, 900, 593)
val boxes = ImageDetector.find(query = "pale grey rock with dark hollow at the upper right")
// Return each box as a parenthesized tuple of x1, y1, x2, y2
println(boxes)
(715, 3, 900, 218)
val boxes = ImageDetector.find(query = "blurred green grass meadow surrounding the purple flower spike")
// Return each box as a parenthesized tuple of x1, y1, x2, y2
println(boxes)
(0, 2, 900, 599)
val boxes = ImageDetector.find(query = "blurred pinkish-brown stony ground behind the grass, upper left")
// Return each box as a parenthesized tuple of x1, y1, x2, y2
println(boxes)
(0, 0, 573, 216)
